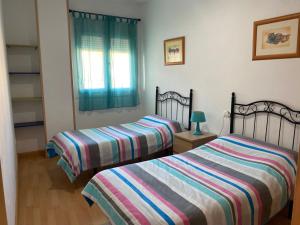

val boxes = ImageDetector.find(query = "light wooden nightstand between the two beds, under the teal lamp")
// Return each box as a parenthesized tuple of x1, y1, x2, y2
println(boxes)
(173, 131, 217, 154)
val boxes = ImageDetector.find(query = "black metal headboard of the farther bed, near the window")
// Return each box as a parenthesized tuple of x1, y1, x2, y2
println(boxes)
(155, 87, 193, 130)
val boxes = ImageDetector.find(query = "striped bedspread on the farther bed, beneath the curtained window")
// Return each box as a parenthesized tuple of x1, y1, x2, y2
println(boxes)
(46, 115, 182, 182)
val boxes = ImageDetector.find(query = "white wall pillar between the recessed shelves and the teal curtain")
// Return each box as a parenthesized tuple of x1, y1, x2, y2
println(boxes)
(37, 0, 74, 139)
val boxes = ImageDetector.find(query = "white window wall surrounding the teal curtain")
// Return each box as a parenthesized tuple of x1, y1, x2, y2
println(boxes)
(69, 0, 146, 128)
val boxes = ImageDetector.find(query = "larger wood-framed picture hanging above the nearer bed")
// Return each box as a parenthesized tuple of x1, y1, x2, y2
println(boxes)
(252, 13, 300, 60)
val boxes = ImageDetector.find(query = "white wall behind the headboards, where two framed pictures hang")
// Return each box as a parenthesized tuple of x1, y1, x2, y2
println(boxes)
(143, 0, 300, 149)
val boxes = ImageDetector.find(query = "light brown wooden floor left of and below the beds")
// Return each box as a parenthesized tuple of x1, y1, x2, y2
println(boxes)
(18, 156, 290, 225)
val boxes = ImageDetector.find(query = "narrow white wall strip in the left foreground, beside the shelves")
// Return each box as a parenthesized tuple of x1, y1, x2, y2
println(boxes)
(0, 1, 17, 225)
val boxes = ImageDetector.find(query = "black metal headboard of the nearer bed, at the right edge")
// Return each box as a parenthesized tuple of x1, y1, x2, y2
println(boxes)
(230, 92, 300, 149)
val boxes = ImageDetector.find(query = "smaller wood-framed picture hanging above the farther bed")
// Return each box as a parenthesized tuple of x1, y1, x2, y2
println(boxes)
(164, 37, 185, 66)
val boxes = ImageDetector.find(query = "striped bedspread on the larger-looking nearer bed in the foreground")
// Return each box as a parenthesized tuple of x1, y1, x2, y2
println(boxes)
(82, 136, 296, 225)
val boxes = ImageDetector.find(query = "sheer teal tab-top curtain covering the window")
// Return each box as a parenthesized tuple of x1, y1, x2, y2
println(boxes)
(70, 11, 139, 111)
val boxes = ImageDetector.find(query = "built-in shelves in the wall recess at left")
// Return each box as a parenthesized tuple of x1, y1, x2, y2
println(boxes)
(6, 44, 45, 153)
